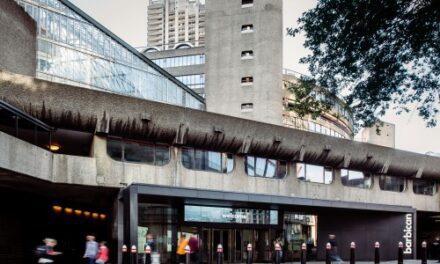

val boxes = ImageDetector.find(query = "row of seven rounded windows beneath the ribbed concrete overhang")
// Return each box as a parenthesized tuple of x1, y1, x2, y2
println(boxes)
(107, 138, 436, 195)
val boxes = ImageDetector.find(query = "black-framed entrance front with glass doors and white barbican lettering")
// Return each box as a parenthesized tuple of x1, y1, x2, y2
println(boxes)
(120, 185, 417, 263)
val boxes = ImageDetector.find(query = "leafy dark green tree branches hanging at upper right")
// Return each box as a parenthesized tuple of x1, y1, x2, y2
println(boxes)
(287, 0, 440, 127)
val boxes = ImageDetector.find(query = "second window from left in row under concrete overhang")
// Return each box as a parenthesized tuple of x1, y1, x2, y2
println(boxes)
(182, 148, 234, 173)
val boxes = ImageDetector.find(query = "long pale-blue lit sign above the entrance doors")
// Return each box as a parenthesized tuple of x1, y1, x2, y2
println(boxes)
(185, 205, 278, 225)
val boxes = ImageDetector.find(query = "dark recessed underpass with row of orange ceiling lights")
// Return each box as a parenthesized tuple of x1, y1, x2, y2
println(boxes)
(0, 170, 118, 264)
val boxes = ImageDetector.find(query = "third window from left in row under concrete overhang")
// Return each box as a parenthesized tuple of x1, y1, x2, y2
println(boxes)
(245, 156, 287, 179)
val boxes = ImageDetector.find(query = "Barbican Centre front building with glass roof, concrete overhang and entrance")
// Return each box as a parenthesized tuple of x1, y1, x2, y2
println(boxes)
(0, 0, 440, 264)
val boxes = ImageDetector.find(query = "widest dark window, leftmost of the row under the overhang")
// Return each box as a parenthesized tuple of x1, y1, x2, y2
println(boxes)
(107, 138, 170, 166)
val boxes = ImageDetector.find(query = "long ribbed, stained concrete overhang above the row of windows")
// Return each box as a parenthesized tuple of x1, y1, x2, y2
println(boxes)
(0, 72, 440, 179)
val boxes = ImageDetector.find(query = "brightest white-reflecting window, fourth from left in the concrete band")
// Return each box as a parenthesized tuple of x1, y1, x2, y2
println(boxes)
(296, 163, 333, 184)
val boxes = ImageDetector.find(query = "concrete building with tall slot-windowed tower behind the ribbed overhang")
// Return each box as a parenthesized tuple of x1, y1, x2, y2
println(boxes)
(143, 0, 353, 138)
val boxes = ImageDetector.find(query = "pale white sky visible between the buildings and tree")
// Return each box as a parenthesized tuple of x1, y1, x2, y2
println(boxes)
(70, 0, 440, 153)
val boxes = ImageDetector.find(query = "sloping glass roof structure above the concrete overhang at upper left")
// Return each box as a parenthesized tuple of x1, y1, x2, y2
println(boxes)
(16, 0, 205, 110)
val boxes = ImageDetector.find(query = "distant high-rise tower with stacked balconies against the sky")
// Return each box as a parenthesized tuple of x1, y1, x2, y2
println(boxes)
(147, 0, 205, 51)
